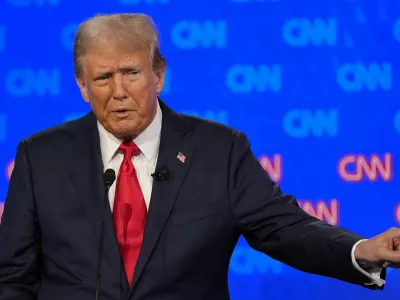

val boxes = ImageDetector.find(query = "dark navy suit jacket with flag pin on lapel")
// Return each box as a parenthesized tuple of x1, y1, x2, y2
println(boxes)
(0, 102, 385, 300)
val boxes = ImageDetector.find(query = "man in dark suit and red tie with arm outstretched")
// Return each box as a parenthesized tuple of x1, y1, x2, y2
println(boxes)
(0, 14, 400, 300)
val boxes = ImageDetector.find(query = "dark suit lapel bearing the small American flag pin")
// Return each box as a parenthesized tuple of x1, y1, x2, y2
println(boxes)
(131, 101, 194, 292)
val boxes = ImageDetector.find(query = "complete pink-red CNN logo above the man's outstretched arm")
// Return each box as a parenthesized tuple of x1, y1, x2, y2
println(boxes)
(338, 153, 393, 182)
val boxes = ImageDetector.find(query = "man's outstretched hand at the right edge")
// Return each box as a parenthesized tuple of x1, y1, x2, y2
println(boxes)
(354, 228, 400, 268)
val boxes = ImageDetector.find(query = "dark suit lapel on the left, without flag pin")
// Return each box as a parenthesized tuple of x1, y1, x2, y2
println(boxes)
(65, 113, 121, 276)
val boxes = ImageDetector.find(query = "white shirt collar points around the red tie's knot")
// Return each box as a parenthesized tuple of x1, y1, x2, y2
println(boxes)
(97, 101, 162, 166)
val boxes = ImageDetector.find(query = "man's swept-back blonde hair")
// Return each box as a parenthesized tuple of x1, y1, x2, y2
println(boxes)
(73, 13, 167, 77)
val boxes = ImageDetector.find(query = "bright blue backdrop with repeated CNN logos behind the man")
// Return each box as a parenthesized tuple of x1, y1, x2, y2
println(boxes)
(0, 0, 400, 300)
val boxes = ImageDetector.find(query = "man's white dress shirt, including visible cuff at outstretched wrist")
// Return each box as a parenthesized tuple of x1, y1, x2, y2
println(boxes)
(97, 101, 385, 286)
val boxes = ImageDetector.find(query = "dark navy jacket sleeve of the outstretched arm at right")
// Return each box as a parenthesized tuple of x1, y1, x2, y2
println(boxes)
(229, 133, 385, 289)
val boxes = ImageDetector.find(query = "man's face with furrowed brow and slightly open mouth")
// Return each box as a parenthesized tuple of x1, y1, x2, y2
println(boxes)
(77, 44, 164, 139)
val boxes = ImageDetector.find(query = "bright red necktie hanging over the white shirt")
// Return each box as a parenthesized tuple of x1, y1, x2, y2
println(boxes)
(113, 141, 147, 286)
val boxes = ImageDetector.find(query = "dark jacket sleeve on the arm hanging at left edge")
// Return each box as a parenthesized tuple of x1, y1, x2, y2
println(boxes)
(0, 142, 40, 300)
